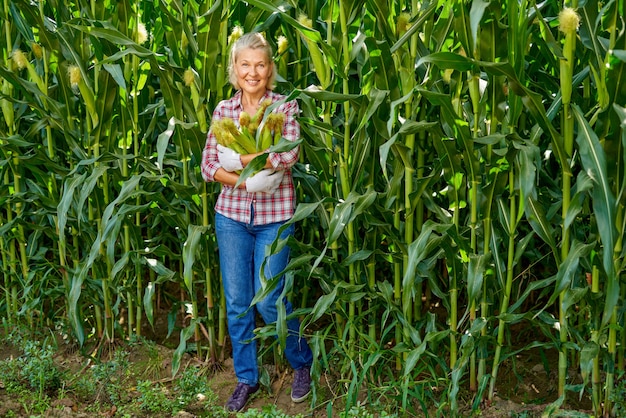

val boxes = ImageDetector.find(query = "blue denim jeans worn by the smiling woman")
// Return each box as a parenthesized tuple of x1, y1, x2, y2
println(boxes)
(215, 213, 313, 385)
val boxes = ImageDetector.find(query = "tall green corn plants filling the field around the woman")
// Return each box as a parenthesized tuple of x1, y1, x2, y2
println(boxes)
(0, 0, 626, 416)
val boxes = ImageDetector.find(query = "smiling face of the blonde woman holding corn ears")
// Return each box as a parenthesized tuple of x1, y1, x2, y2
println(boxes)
(234, 48, 272, 96)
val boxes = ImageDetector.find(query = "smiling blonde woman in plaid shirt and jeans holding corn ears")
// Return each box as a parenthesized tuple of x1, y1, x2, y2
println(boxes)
(202, 33, 313, 411)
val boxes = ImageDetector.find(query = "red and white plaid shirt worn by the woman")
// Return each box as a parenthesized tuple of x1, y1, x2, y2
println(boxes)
(201, 90, 300, 225)
